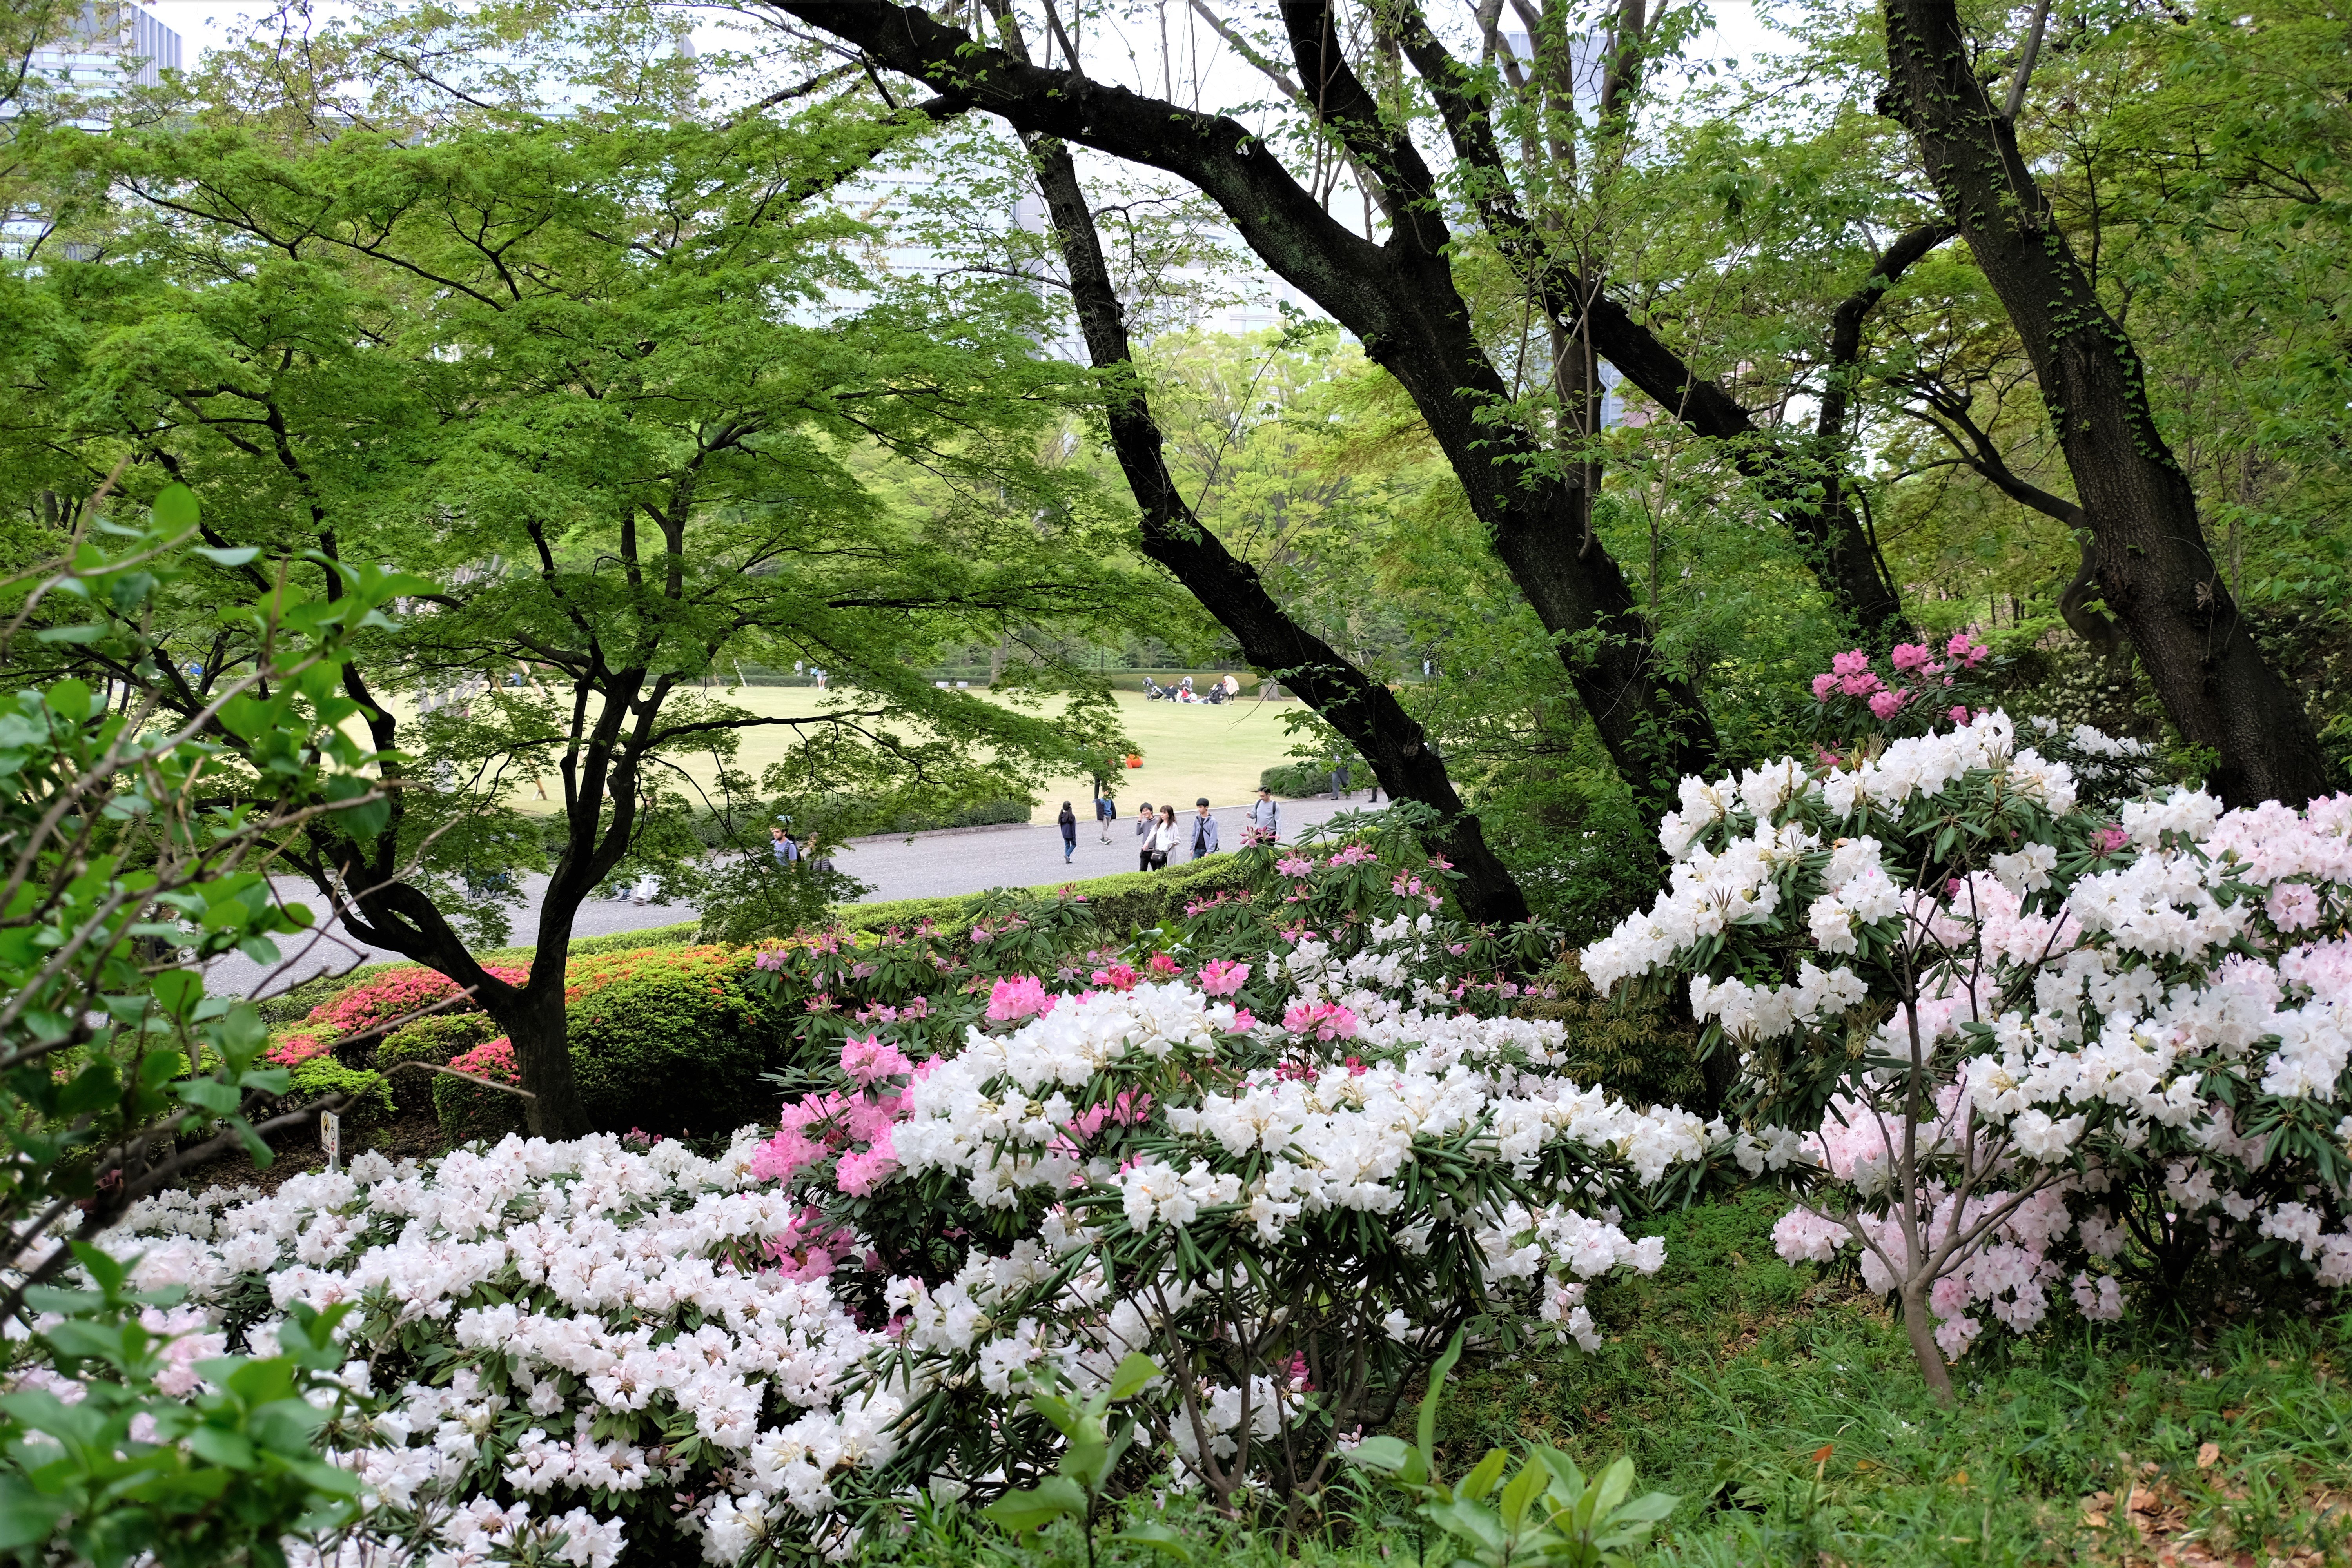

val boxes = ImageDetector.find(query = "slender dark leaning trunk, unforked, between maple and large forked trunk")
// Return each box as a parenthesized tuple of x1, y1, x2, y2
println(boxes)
(1030, 139, 1526, 924)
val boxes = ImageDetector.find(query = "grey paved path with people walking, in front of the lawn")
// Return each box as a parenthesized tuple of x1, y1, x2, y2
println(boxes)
(205, 797, 1364, 997)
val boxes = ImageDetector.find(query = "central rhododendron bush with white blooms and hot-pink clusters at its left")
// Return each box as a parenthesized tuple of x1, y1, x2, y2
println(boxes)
(753, 968, 1719, 1533)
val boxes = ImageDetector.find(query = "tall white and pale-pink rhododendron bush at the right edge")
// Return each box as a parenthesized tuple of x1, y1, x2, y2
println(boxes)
(1583, 712, 2352, 1389)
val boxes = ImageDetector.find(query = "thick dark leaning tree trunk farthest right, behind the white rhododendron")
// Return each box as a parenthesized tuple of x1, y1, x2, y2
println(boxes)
(1879, 0, 2331, 806)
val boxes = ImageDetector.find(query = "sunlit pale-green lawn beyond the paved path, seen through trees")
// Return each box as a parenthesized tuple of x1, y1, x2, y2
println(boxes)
(376, 684, 1298, 823)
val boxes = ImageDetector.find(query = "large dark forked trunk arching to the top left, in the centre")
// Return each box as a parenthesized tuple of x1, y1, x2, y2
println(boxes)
(771, 0, 1715, 820)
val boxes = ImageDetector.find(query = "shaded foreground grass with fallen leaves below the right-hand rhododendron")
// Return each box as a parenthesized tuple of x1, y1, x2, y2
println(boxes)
(868, 1194, 2352, 1568)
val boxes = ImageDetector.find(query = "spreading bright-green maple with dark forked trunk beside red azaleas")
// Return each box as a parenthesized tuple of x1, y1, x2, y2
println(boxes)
(0, 113, 1134, 1136)
